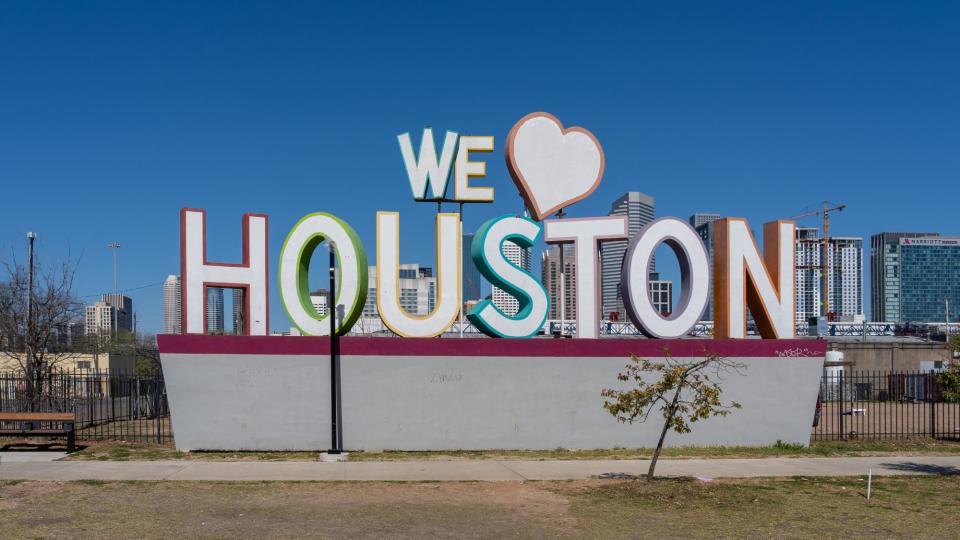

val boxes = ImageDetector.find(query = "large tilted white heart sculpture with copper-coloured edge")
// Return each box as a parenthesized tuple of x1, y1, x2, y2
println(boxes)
(506, 112, 604, 220)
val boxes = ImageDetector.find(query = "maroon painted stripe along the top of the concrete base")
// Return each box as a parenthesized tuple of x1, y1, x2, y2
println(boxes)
(157, 334, 827, 358)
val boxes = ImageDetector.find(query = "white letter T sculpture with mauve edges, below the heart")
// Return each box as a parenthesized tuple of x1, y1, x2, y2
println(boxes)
(543, 216, 628, 338)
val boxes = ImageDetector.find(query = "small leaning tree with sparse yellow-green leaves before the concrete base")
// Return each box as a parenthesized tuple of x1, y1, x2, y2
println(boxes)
(601, 350, 746, 479)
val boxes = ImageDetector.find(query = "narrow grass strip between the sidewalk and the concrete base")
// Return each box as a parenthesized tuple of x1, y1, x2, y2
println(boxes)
(56, 439, 960, 461)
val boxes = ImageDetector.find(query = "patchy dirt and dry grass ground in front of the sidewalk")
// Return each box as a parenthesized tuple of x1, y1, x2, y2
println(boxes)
(0, 476, 960, 539)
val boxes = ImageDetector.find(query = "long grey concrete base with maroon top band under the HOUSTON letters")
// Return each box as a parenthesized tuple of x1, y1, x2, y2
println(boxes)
(160, 336, 825, 450)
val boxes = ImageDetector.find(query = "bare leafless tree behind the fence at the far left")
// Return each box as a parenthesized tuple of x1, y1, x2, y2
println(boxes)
(0, 251, 83, 409)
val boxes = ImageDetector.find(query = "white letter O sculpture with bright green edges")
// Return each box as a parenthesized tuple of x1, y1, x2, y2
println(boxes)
(280, 212, 367, 336)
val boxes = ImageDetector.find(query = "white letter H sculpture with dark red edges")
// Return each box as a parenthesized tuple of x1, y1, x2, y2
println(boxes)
(180, 208, 270, 336)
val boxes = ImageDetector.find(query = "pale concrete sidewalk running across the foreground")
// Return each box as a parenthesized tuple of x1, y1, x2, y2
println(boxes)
(0, 456, 960, 481)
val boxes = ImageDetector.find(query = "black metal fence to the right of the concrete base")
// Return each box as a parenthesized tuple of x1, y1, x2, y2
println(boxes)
(812, 371, 960, 440)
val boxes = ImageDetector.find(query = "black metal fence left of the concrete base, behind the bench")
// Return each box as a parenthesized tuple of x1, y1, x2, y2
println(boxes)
(0, 370, 173, 444)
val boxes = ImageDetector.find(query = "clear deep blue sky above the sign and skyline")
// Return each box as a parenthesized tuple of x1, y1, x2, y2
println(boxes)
(0, 1, 960, 331)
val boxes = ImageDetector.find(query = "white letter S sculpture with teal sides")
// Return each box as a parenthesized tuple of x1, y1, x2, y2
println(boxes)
(467, 215, 550, 337)
